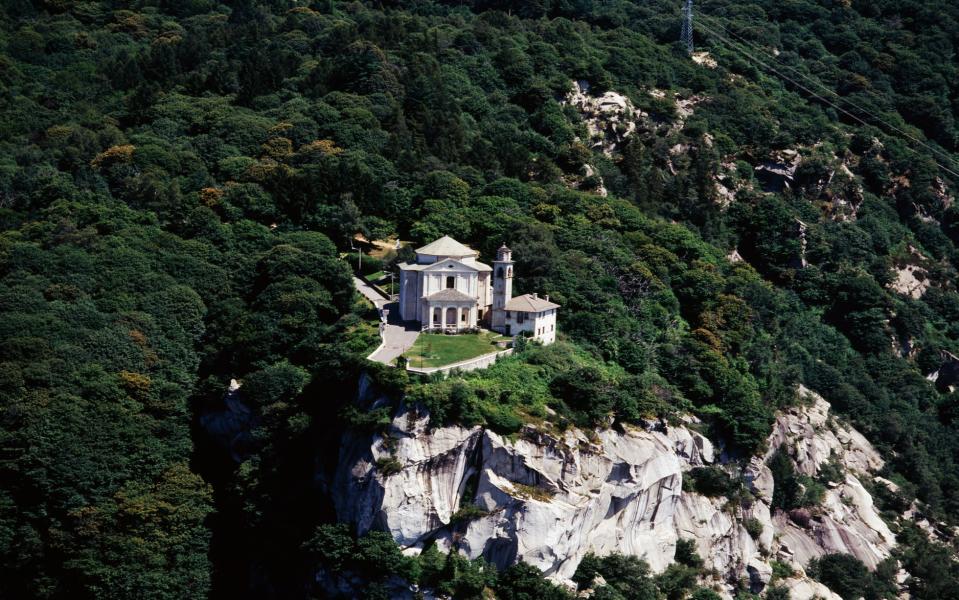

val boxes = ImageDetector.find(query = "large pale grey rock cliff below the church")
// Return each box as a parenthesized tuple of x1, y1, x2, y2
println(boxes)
(333, 388, 895, 598)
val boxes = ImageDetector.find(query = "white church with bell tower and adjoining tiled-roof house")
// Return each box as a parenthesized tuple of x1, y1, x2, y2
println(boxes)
(399, 236, 559, 344)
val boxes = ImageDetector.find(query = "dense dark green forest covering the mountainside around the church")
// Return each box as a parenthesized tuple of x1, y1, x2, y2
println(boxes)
(0, 0, 959, 600)
